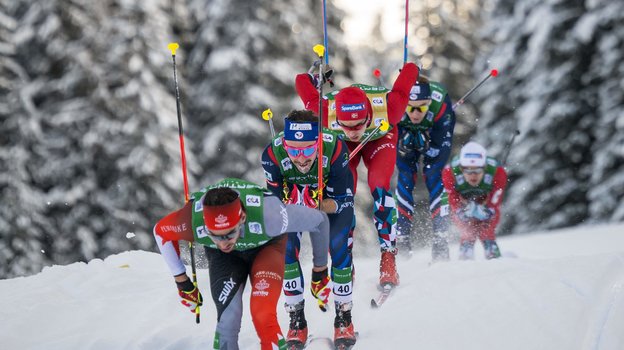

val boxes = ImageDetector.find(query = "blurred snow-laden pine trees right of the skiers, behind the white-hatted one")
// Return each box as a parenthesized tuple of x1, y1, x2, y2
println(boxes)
(475, 0, 624, 232)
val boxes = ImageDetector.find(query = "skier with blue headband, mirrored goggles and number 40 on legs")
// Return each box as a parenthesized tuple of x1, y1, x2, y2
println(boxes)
(262, 110, 355, 348)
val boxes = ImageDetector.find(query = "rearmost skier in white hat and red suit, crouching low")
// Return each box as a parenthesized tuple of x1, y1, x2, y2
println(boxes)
(442, 142, 507, 260)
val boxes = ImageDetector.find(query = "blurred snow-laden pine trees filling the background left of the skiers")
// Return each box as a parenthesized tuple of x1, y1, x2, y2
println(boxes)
(0, 0, 344, 277)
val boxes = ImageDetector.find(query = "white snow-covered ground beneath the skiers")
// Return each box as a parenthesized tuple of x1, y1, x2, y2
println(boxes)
(0, 225, 624, 350)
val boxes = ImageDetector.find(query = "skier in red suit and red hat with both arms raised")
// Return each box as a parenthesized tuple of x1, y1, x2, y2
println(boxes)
(295, 63, 418, 286)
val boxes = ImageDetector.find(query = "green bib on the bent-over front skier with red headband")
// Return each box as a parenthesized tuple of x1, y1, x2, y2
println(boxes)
(191, 178, 271, 251)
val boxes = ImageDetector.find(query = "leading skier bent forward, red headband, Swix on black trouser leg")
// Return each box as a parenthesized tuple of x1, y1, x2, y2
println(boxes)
(154, 179, 329, 350)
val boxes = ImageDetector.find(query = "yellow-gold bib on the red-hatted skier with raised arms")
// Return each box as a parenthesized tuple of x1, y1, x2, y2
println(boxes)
(325, 84, 392, 141)
